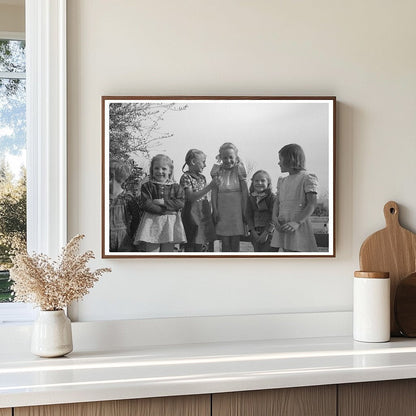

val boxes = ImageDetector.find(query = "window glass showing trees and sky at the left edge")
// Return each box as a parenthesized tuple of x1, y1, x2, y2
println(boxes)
(0, 39, 26, 303)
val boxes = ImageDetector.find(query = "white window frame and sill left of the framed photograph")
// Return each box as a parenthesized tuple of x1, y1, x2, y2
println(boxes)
(0, 0, 67, 323)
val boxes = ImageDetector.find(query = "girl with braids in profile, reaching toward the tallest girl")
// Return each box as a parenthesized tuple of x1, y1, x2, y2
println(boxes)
(180, 149, 216, 252)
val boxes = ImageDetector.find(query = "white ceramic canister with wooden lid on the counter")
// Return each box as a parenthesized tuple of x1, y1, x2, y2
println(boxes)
(353, 271, 390, 342)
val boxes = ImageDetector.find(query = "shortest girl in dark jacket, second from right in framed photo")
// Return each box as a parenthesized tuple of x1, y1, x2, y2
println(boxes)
(247, 170, 276, 252)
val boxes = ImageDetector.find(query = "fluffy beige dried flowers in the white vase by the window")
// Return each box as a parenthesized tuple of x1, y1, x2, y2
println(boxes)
(10, 234, 111, 311)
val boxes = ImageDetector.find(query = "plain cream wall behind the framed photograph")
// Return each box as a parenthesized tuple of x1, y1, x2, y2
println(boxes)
(68, 0, 416, 321)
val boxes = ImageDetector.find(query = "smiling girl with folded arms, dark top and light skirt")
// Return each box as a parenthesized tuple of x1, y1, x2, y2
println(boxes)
(134, 154, 186, 252)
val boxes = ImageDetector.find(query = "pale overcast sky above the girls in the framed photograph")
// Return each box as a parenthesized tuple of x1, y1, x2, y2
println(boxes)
(128, 100, 332, 198)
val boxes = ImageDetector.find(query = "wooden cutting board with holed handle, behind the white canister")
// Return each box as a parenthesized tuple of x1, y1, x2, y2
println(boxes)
(360, 201, 416, 336)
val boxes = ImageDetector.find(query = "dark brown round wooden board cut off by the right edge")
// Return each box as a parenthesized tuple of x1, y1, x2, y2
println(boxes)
(394, 273, 416, 337)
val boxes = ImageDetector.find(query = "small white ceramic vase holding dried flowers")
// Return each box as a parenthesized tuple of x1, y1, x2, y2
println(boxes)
(31, 310, 72, 358)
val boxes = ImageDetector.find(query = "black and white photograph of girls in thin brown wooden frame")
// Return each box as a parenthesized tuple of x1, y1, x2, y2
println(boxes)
(102, 96, 336, 258)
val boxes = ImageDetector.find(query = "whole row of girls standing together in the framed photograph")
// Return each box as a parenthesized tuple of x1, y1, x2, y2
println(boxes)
(110, 142, 318, 252)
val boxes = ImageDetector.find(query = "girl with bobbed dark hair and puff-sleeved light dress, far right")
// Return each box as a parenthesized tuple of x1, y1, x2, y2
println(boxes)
(271, 144, 318, 252)
